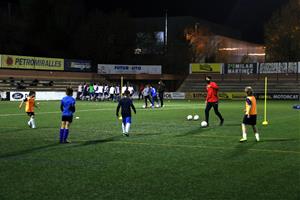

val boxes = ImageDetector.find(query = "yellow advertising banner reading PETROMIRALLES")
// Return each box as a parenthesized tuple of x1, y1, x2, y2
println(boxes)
(1, 55, 64, 70)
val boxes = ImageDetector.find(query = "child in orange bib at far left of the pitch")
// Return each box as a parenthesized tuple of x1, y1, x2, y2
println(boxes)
(19, 91, 39, 128)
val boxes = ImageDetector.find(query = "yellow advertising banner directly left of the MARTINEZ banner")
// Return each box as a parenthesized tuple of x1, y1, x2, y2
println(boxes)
(190, 63, 223, 74)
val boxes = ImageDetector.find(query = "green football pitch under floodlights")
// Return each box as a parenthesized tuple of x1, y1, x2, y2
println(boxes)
(0, 100, 300, 200)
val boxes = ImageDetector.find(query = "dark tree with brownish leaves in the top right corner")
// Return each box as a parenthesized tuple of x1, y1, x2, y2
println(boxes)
(265, 0, 300, 62)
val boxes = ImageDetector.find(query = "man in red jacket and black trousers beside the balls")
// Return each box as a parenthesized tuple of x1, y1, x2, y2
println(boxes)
(205, 76, 224, 126)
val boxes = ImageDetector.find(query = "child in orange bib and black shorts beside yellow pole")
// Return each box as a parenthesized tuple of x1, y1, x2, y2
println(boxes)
(240, 87, 259, 142)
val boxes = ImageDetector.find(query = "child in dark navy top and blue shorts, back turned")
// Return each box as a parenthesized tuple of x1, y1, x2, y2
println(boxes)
(116, 90, 136, 136)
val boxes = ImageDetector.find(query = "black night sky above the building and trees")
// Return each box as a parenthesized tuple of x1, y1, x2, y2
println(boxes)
(88, 0, 288, 43)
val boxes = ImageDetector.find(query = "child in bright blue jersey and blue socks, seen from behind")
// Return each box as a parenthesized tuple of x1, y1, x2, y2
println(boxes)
(59, 88, 75, 143)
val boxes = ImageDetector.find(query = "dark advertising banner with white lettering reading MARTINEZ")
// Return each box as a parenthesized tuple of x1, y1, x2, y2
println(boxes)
(224, 63, 257, 74)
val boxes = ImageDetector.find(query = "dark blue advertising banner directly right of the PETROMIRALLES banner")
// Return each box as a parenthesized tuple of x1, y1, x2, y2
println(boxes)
(65, 59, 92, 72)
